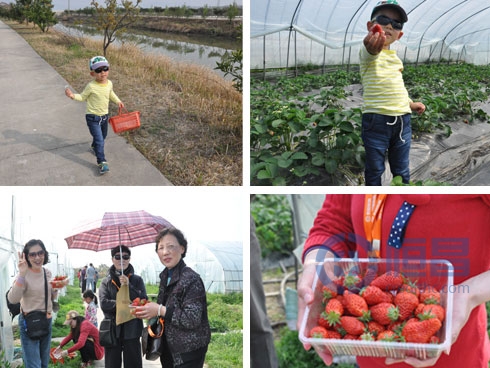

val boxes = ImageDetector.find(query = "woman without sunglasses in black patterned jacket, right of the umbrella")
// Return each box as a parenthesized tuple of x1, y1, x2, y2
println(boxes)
(136, 228, 211, 368)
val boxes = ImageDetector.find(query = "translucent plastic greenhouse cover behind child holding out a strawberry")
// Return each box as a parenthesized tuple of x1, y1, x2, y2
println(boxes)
(250, 0, 490, 68)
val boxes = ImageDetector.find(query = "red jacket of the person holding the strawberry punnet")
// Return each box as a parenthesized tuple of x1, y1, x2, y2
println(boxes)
(303, 194, 490, 368)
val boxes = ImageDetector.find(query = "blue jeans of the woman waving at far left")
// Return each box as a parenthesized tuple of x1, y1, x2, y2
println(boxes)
(19, 313, 52, 368)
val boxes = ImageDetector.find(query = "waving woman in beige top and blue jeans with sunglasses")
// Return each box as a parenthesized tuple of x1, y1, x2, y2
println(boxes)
(7, 239, 68, 368)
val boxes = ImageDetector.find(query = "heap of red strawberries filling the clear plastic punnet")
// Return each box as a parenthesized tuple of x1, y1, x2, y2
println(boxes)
(309, 270, 446, 344)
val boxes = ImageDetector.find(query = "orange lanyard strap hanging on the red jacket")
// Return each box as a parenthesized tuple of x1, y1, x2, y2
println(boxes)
(364, 194, 387, 258)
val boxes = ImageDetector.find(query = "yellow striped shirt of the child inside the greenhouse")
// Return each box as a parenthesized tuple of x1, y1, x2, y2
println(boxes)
(359, 47, 412, 116)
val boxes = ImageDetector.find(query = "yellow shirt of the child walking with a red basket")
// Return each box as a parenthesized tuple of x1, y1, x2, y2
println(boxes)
(73, 80, 121, 116)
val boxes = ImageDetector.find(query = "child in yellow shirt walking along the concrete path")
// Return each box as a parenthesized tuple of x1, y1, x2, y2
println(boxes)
(65, 56, 124, 175)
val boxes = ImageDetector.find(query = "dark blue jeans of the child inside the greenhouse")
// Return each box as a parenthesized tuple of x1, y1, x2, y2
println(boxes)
(361, 114, 412, 185)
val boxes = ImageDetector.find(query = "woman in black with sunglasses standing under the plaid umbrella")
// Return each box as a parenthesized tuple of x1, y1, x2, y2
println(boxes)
(99, 245, 148, 368)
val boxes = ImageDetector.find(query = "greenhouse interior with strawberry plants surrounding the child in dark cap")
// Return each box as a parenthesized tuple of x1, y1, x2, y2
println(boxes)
(250, 0, 490, 186)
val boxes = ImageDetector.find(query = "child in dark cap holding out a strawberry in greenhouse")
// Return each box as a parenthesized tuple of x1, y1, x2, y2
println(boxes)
(359, 0, 425, 185)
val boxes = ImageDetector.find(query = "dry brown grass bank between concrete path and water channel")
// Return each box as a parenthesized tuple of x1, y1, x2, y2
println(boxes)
(5, 21, 242, 186)
